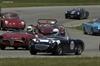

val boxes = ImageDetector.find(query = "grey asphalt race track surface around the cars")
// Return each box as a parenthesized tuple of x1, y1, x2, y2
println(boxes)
(0, 5, 100, 58)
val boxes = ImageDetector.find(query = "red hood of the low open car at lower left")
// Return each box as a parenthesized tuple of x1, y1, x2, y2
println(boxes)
(2, 32, 32, 39)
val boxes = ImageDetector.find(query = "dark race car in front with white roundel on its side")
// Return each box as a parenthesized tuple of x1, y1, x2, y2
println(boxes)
(29, 36, 84, 55)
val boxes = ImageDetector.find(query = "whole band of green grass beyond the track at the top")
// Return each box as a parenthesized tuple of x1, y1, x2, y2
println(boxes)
(0, 0, 100, 7)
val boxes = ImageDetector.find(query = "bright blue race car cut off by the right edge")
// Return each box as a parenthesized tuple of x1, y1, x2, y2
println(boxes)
(82, 18, 100, 35)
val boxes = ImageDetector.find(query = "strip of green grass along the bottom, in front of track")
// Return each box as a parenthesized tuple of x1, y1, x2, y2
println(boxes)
(0, 57, 100, 66)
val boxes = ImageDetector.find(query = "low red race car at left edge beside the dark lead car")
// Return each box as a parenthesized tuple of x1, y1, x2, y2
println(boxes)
(0, 30, 34, 50)
